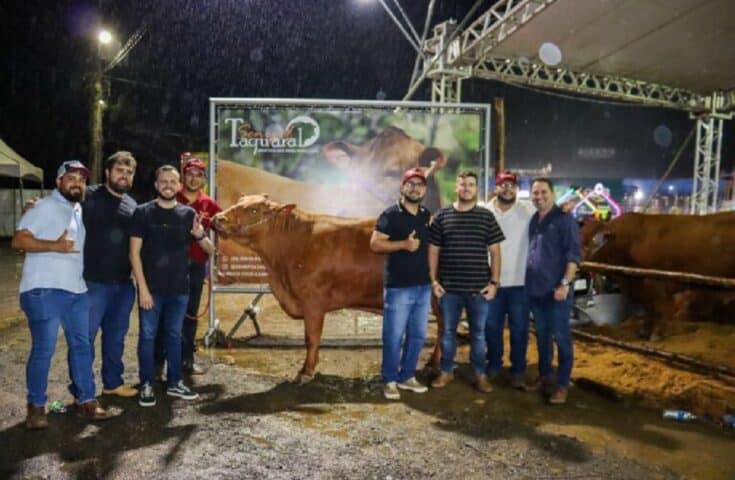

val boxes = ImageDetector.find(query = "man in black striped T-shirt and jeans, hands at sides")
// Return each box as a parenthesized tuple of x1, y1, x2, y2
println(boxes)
(429, 171, 505, 392)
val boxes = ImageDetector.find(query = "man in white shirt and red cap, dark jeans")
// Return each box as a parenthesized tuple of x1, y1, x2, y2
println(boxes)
(485, 171, 534, 389)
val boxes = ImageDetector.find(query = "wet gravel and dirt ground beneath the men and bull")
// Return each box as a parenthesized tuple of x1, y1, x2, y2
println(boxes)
(0, 260, 735, 479)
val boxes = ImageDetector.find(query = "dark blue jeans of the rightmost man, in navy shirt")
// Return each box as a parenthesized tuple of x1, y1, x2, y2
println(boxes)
(529, 293, 574, 388)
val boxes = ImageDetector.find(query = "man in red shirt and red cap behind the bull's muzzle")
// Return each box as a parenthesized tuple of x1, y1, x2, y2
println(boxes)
(156, 155, 222, 375)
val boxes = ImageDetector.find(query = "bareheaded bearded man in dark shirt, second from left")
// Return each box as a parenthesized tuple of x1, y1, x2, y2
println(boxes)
(82, 151, 138, 397)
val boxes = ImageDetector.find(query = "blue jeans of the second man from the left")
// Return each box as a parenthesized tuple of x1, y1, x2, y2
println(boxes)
(87, 280, 135, 390)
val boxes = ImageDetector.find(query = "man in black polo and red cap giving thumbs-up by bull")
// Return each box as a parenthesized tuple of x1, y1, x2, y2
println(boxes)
(370, 168, 431, 400)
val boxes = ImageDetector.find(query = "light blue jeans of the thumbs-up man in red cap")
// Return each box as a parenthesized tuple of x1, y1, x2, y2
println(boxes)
(380, 285, 431, 383)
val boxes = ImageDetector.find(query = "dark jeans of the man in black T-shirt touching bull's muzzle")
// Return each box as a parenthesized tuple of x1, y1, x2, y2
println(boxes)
(138, 293, 189, 386)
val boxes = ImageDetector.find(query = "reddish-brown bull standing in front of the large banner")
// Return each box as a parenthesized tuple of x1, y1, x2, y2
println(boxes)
(212, 195, 384, 382)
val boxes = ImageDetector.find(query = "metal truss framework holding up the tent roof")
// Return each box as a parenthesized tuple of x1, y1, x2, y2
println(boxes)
(403, 0, 735, 214)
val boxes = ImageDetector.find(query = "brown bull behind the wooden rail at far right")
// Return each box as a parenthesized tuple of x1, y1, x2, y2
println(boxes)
(581, 212, 735, 340)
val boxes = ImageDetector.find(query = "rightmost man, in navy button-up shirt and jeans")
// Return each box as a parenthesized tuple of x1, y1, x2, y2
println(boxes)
(526, 178, 580, 404)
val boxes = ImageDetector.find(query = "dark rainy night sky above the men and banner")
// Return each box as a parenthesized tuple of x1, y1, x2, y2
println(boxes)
(0, 0, 735, 195)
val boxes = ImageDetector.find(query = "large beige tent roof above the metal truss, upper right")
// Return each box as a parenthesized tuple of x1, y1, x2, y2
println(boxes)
(488, 0, 735, 94)
